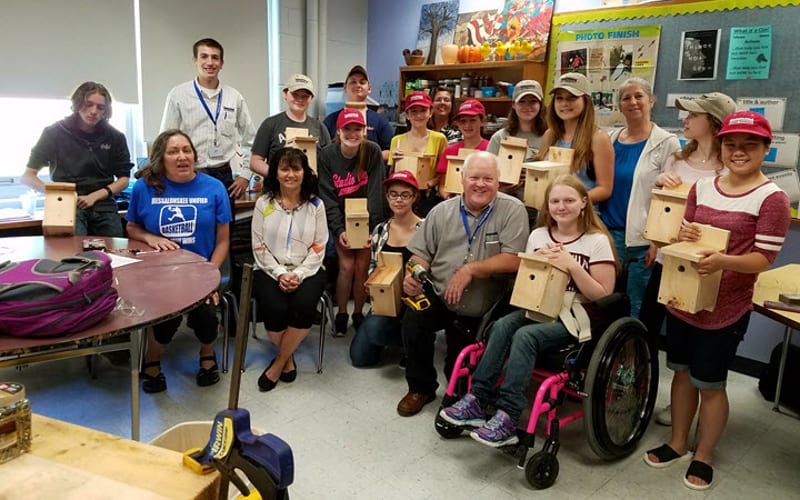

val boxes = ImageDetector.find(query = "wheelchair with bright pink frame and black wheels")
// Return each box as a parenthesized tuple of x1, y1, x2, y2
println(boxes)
(435, 293, 658, 489)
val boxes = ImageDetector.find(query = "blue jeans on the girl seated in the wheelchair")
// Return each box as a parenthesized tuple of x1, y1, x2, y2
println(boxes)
(470, 309, 573, 422)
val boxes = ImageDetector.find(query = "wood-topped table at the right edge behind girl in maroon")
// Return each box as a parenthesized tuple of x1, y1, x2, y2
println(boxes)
(753, 264, 800, 412)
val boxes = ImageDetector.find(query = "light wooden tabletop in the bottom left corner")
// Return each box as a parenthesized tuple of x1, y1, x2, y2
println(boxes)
(0, 414, 220, 500)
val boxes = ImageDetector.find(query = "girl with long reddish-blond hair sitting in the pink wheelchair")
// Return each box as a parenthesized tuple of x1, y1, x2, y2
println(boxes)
(440, 175, 616, 447)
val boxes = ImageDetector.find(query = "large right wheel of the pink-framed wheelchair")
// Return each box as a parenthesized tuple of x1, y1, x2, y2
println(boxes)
(583, 317, 658, 460)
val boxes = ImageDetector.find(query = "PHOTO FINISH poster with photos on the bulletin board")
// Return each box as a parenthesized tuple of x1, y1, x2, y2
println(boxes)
(548, 25, 661, 126)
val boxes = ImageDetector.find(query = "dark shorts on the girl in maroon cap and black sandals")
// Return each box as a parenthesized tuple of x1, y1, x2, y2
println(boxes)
(667, 311, 750, 389)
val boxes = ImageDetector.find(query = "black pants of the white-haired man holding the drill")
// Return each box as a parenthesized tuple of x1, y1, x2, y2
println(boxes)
(402, 287, 481, 394)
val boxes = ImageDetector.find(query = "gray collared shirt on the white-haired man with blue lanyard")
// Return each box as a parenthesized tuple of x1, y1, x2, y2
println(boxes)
(408, 193, 528, 317)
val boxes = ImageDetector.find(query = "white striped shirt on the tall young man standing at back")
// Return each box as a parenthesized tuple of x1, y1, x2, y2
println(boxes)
(161, 80, 256, 179)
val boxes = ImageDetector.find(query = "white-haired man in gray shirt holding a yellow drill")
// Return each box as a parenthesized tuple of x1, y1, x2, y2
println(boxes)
(397, 151, 528, 417)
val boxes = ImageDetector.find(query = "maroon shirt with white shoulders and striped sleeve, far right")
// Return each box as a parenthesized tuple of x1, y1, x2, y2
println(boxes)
(667, 177, 791, 330)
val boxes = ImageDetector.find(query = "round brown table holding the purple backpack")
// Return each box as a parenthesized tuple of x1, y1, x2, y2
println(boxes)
(0, 236, 220, 440)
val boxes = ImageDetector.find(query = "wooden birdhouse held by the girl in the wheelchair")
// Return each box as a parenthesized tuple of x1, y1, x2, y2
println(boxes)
(511, 254, 569, 323)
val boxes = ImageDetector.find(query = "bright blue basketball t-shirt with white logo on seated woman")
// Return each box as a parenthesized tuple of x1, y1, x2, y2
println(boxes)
(125, 173, 232, 259)
